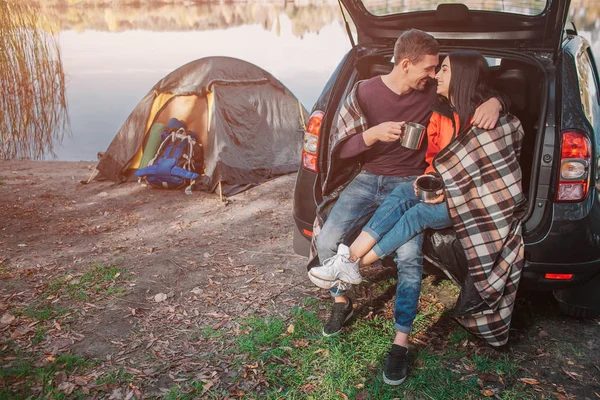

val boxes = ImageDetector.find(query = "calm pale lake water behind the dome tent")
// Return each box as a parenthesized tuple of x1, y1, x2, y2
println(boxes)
(29, 0, 600, 161)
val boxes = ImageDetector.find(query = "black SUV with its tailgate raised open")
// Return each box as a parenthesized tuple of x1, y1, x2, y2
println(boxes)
(294, 0, 600, 317)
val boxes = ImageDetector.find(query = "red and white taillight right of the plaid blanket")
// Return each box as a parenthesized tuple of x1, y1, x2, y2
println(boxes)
(556, 132, 591, 202)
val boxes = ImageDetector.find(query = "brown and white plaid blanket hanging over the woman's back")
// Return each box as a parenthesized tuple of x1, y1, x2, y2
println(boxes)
(433, 115, 525, 346)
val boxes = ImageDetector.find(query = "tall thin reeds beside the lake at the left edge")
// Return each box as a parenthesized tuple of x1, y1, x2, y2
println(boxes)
(0, 0, 68, 159)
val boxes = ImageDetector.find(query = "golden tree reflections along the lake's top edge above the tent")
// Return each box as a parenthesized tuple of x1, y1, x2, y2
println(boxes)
(25, 0, 339, 36)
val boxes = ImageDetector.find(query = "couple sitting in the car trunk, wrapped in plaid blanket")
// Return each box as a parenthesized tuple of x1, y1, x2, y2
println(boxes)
(309, 30, 524, 385)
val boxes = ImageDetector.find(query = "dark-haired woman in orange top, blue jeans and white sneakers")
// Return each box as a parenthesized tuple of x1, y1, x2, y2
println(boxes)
(309, 50, 522, 284)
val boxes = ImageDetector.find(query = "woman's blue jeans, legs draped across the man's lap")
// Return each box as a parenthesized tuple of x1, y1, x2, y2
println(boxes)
(363, 182, 452, 258)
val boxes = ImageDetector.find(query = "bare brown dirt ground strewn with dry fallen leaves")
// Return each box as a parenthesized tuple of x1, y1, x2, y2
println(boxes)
(0, 161, 600, 399)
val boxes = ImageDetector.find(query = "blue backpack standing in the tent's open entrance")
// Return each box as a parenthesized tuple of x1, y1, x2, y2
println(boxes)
(135, 118, 203, 190)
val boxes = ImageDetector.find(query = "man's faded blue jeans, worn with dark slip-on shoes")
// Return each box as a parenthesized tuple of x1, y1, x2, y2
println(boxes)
(317, 171, 423, 334)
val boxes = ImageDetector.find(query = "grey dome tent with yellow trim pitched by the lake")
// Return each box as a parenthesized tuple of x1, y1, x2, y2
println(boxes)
(97, 57, 307, 195)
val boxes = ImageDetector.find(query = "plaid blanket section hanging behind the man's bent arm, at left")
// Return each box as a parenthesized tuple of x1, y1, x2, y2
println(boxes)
(307, 81, 368, 262)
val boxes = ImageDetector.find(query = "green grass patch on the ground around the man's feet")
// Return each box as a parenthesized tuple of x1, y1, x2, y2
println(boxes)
(234, 300, 534, 399)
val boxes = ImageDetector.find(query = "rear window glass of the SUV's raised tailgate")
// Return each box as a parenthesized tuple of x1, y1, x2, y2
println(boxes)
(362, 0, 548, 16)
